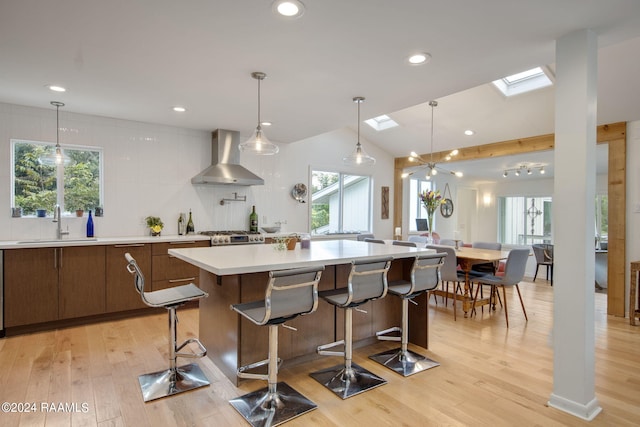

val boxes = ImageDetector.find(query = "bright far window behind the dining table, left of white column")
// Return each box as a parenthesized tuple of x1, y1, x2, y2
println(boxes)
(498, 196, 552, 245)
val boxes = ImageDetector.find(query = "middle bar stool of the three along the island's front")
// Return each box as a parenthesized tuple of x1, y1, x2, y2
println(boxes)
(310, 257, 393, 399)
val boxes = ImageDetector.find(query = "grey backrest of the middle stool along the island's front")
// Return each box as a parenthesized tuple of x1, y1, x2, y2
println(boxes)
(345, 257, 393, 305)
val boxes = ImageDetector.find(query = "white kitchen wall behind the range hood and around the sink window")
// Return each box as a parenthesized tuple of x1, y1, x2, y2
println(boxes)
(0, 103, 393, 240)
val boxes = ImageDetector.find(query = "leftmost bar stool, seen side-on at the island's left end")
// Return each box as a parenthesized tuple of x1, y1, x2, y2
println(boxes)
(124, 252, 209, 402)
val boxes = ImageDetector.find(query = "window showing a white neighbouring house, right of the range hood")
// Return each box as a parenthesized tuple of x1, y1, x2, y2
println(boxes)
(311, 171, 372, 234)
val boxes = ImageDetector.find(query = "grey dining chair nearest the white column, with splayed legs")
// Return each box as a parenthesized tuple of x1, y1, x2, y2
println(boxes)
(471, 248, 529, 328)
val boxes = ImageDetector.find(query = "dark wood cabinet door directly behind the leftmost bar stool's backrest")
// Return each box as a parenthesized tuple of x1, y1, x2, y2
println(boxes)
(106, 243, 152, 313)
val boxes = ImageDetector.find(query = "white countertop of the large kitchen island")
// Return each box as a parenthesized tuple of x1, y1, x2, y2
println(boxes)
(169, 240, 435, 276)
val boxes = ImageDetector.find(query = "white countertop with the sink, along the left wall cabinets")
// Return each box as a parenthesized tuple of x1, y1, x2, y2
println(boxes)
(0, 234, 210, 249)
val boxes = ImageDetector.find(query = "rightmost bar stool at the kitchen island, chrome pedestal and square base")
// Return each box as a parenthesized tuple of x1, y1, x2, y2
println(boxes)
(369, 253, 446, 377)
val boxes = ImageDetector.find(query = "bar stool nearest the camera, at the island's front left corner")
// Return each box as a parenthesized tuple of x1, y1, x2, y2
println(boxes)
(229, 266, 324, 426)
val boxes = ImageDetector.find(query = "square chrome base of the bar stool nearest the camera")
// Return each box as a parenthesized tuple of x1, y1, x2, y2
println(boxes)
(229, 382, 318, 427)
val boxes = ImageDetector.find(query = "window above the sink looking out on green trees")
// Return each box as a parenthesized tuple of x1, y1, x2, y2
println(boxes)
(11, 140, 102, 216)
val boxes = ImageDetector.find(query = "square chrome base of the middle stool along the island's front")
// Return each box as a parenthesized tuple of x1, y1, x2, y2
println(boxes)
(309, 363, 387, 399)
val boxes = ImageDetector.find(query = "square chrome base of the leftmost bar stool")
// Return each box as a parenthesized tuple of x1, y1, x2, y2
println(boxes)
(138, 363, 209, 402)
